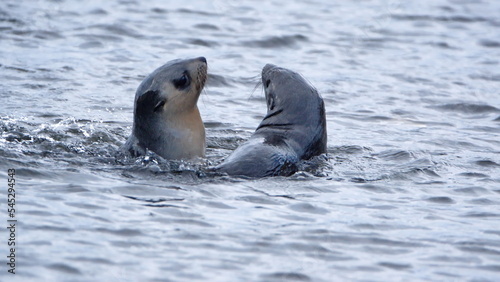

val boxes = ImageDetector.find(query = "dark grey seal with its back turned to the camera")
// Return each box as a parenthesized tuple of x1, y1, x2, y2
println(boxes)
(216, 64, 327, 177)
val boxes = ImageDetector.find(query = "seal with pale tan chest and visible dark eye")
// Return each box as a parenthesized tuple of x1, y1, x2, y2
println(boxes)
(123, 57, 207, 159)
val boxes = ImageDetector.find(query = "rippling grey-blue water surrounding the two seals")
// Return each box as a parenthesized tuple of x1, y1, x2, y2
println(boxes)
(0, 0, 500, 281)
